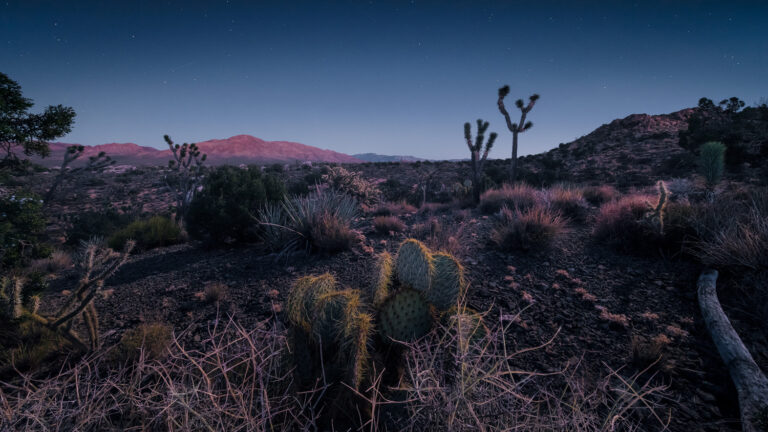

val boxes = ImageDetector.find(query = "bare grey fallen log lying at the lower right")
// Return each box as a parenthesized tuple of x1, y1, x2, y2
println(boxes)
(698, 270, 768, 432)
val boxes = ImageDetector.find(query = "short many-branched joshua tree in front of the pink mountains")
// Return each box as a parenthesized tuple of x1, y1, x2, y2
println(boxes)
(163, 135, 208, 224)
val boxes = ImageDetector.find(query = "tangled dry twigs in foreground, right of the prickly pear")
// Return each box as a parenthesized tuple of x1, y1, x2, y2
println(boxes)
(400, 308, 668, 432)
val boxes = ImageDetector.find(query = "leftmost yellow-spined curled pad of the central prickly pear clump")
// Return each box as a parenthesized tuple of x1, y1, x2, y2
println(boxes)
(286, 273, 336, 332)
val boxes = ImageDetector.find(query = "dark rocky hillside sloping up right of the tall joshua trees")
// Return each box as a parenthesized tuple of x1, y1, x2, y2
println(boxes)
(521, 108, 695, 186)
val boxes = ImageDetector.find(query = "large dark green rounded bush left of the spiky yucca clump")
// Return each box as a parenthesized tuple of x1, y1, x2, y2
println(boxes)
(186, 166, 285, 244)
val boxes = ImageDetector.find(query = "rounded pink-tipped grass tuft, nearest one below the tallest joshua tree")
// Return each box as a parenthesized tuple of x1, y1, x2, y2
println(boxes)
(491, 205, 565, 251)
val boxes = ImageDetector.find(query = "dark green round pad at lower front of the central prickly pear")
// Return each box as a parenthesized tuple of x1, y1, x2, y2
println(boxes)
(379, 288, 432, 342)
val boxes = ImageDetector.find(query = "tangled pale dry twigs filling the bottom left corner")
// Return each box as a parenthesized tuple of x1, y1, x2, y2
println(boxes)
(0, 320, 318, 431)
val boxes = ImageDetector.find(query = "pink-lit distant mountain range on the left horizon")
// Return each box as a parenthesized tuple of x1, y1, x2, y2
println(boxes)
(33, 135, 362, 167)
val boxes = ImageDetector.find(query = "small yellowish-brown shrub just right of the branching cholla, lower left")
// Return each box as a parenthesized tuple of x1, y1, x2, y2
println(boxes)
(112, 323, 173, 363)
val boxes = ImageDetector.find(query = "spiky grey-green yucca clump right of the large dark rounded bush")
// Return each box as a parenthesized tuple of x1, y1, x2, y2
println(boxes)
(258, 190, 359, 253)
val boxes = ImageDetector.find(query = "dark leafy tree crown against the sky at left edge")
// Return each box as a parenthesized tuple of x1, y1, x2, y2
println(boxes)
(0, 73, 75, 166)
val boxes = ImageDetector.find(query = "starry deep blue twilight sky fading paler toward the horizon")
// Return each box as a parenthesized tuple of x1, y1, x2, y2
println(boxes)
(0, 0, 768, 159)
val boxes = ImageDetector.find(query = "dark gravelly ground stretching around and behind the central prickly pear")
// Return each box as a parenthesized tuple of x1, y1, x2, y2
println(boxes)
(34, 197, 768, 431)
